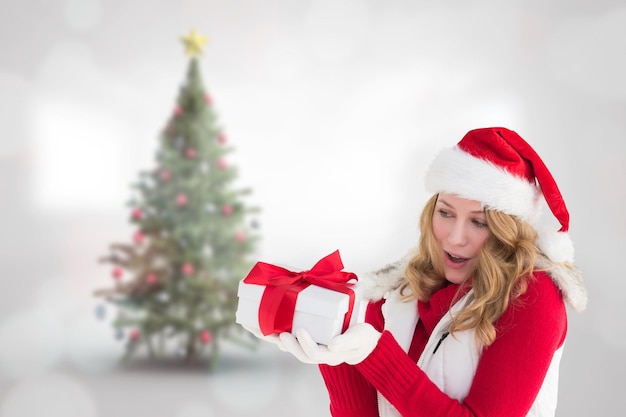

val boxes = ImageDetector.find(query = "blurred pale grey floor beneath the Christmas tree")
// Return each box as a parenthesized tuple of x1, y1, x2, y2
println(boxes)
(0, 344, 329, 417)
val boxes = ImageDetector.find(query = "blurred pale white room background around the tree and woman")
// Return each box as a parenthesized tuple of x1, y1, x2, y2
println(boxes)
(0, 0, 626, 417)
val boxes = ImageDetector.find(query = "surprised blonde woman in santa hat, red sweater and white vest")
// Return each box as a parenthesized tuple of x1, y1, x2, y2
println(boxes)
(254, 128, 586, 417)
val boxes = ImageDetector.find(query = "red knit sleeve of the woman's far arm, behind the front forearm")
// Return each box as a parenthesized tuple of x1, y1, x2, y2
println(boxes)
(319, 301, 384, 417)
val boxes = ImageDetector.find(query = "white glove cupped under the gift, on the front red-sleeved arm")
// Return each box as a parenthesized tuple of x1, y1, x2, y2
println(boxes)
(279, 323, 380, 366)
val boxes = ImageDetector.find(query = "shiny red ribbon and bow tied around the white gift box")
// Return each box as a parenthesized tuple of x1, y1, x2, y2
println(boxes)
(243, 251, 358, 336)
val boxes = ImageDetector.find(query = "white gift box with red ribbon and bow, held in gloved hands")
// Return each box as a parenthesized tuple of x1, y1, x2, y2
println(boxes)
(235, 251, 365, 344)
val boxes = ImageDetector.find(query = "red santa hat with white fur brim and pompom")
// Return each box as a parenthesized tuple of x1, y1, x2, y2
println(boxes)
(425, 127, 574, 262)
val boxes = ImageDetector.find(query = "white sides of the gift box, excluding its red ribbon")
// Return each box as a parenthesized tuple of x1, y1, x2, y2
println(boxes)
(235, 280, 366, 345)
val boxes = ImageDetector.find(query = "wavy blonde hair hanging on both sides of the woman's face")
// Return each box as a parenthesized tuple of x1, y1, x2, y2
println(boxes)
(401, 194, 540, 346)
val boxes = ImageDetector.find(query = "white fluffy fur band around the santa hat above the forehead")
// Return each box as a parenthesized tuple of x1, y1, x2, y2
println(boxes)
(425, 146, 541, 224)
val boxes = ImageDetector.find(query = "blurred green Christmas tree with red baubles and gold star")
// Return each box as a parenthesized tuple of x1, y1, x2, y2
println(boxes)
(96, 31, 258, 362)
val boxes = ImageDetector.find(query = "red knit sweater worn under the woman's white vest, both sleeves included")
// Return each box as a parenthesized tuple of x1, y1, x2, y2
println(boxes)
(320, 272, 567, 417)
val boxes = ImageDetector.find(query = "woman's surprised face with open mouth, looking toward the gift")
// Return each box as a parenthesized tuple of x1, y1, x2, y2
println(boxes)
(433, 193, 491, 284)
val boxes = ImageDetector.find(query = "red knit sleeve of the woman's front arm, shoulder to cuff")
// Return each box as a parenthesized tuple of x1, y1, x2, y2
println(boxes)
(356, 273, 567, 417)
